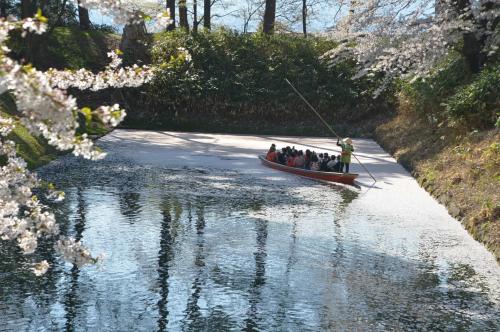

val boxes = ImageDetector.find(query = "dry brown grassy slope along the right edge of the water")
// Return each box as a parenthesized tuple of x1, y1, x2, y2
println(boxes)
(376, 114, 500, 261)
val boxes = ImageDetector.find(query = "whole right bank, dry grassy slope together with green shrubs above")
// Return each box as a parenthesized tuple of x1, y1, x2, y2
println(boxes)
(375, 57, 500, 262)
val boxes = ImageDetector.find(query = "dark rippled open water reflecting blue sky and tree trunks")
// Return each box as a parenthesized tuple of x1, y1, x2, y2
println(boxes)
(0, 152, 500, 331)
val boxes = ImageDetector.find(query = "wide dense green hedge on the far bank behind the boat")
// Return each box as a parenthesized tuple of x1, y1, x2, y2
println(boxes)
(134, 29, 390, 134)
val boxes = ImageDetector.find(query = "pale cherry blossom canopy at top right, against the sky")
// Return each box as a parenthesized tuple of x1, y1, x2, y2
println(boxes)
(324, 0, 500, 93)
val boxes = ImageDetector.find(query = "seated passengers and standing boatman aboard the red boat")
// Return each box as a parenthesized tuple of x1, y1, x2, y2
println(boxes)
(266, 138, 354, 173)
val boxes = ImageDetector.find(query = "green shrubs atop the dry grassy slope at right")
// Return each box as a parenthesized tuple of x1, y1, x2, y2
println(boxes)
(400, 52, 500, 130)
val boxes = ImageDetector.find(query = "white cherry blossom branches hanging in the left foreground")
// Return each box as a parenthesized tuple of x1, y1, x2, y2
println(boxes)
(0, 0, 186, 275)
